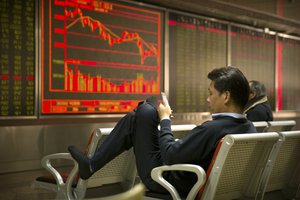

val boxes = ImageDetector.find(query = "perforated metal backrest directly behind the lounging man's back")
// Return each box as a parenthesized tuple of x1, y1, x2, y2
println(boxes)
(198, 132, 279, 200)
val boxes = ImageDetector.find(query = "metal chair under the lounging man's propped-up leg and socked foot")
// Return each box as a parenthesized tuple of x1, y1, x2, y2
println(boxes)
(31, 128, 136, 199)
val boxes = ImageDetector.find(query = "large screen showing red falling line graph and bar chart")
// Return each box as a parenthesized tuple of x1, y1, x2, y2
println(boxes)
(41, 0, 163, 114)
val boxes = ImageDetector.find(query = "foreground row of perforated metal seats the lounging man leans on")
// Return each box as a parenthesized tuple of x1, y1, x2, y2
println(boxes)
(151, 131, 300, 200)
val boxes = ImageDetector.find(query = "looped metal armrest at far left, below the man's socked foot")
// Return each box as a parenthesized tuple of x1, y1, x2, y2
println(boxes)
(41, 153, 78, 188)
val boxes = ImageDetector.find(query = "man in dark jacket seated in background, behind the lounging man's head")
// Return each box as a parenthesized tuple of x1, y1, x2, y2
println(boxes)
(244, 80, 273, 122)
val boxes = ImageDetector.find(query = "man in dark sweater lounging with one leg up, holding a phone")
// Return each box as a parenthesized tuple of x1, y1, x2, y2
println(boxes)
(69, 67, 256, 195)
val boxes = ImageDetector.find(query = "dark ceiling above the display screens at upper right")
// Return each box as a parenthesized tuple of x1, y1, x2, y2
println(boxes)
(135, 0, 300, 36)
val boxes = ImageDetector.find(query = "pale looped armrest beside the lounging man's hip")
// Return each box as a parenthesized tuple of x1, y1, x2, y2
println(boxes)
(151, 164, 206, 200)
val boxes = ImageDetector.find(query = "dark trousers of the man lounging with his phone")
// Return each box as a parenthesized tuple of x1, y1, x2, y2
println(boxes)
(91, 102, 166, 193)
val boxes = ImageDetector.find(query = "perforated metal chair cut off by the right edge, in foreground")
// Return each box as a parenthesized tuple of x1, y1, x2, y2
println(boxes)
(257, 131, 300, 199)
